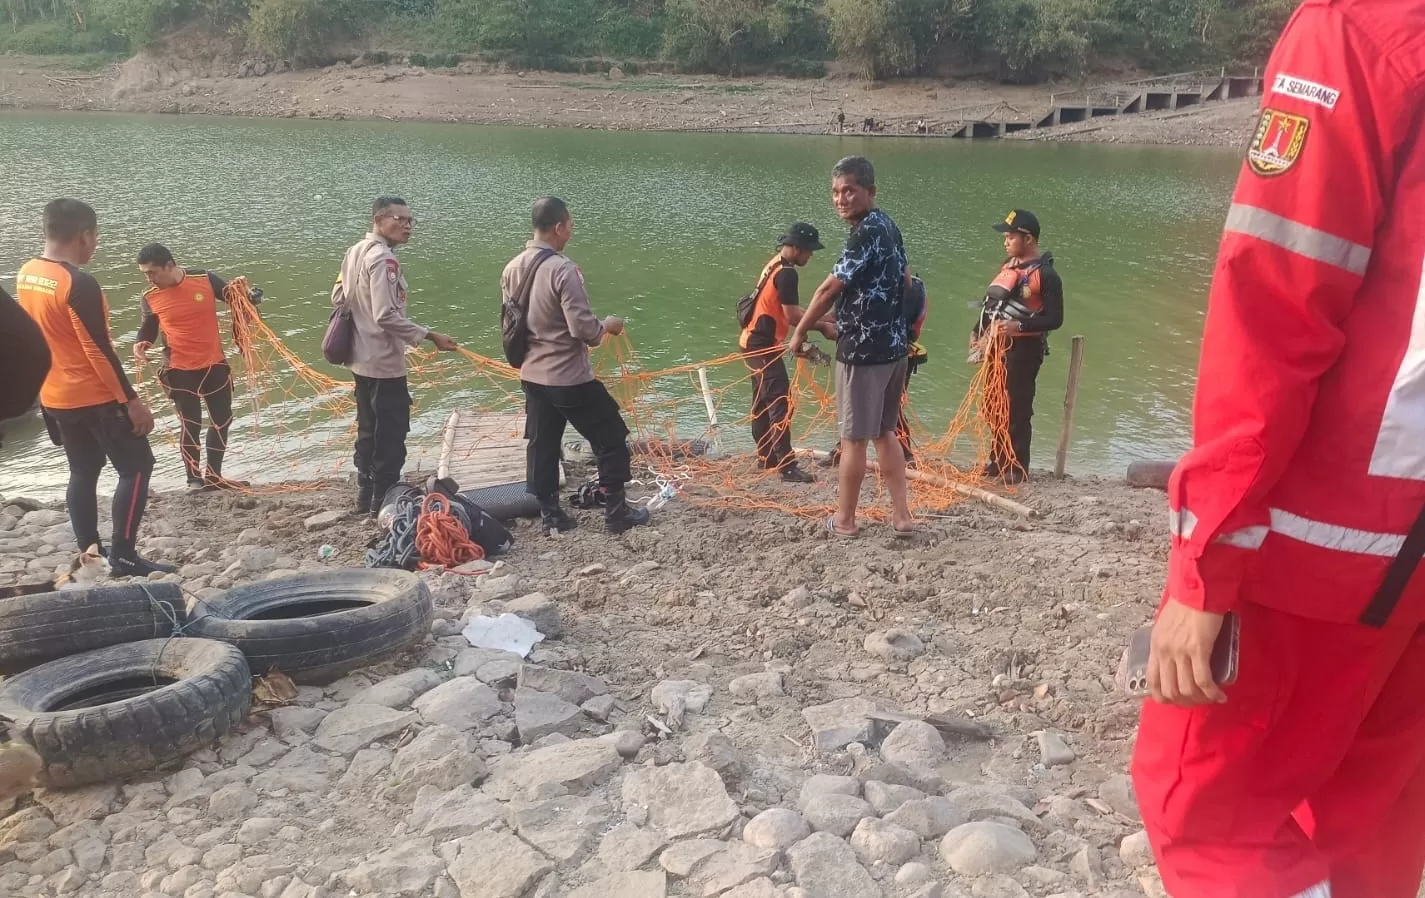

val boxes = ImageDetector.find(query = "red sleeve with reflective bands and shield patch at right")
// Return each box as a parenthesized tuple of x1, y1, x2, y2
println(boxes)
(1166, 0, 1419, 613)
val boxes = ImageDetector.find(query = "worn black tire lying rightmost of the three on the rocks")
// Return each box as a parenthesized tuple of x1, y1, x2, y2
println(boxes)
(187, 567, 435, 683)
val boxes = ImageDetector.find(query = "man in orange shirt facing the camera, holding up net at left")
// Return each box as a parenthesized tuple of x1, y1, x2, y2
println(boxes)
(134, 244, 256, 490)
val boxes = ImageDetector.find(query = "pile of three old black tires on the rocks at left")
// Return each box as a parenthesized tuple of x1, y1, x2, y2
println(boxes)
(0, 569, 433, 788)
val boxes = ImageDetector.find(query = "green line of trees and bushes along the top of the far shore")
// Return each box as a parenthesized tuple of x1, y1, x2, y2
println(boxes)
(0, 0, 1297, 83)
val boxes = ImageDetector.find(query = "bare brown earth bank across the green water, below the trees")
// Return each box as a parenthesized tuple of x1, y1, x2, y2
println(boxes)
(0, 56, 1255, 147)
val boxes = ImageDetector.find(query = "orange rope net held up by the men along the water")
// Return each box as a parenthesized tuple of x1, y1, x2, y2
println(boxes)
(128, 278, 1009, 519)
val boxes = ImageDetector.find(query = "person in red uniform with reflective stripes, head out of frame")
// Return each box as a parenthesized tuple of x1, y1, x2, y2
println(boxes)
(1133, 0, 1425, 898)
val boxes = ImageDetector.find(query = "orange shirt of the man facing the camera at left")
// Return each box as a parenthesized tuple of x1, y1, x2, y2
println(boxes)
(138, 268, 228, 371)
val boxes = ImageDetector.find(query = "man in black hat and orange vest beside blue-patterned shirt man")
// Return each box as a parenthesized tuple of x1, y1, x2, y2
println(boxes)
(737, 221, 835, 483)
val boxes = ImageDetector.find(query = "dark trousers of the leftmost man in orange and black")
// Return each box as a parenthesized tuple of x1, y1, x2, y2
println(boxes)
(44, 402, 154, 557)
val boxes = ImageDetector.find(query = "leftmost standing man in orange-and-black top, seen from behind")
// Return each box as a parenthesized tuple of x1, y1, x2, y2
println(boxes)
(16, 200, 174, 577)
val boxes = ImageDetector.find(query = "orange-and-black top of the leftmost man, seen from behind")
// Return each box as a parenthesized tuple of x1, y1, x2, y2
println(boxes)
(16, 258, 135, 409)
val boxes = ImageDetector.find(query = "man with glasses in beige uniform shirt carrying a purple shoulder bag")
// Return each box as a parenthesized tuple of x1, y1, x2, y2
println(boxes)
(332, 197, 459, 515)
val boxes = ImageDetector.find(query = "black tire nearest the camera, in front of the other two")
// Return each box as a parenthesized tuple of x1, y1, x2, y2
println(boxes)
(0, 637, 252, 788)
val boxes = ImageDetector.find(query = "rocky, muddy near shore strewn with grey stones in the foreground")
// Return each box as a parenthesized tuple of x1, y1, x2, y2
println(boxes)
(0, 470, 1166, 898)
